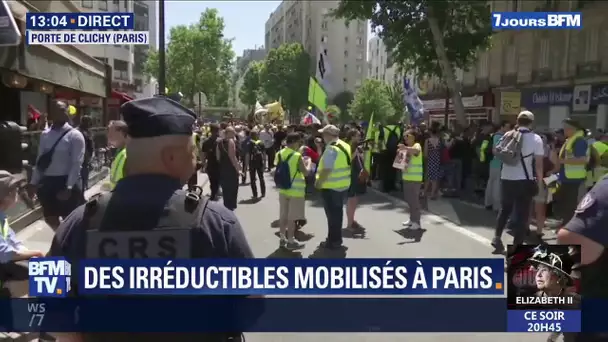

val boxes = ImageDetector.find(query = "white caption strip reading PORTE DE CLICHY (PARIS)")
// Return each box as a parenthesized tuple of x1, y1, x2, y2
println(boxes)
(25, 30, 150, 45)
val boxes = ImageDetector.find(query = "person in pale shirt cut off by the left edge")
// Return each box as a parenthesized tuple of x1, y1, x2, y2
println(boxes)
(0, 170, 44, 297)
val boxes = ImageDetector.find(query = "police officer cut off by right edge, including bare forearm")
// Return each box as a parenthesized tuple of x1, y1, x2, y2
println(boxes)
(557, 176, 608, 342)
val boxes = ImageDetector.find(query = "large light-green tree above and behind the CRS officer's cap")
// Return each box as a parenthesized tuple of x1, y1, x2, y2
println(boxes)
(145, 8, 234, 105)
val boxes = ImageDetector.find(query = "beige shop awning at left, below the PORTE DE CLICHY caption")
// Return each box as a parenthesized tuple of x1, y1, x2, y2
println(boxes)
(0, 1, 108, 97)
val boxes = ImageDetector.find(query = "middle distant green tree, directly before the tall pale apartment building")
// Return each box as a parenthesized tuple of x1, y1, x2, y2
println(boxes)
(260, 43, 311, 120)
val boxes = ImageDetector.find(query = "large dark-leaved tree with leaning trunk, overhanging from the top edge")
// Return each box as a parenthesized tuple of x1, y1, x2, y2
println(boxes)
(333, 0, 492, 124)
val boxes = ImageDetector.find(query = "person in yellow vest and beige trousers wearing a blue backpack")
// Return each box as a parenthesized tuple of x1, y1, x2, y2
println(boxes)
(276, 133, 310, 250)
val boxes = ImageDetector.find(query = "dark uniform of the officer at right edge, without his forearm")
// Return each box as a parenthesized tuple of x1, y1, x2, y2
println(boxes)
(563, 177, 608, 342)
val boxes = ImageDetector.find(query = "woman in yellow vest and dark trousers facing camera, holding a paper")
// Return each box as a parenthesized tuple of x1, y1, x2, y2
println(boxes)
(399, 131, 424, 229)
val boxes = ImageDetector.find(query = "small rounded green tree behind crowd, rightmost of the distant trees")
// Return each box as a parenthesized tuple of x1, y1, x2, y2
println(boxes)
(348, 79, 395, 123)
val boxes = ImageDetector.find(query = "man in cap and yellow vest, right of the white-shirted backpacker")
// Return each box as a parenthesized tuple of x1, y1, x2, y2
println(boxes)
(554, 119, 590, 223)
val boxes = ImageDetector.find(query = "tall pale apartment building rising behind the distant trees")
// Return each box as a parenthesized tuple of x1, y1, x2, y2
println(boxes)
(265, 1, 367, 98)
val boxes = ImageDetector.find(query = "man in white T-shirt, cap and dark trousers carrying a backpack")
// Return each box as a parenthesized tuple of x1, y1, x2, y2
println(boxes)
(492, 110, 545, 253)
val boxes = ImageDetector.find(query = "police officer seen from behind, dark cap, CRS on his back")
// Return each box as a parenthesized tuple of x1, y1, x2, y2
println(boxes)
(49, 97, 253, 342)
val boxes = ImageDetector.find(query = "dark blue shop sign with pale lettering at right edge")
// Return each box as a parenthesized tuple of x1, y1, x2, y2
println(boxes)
(521, 84, 608, 111)
